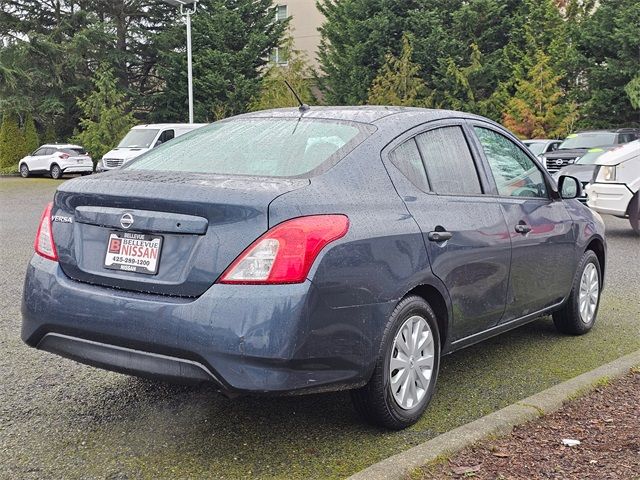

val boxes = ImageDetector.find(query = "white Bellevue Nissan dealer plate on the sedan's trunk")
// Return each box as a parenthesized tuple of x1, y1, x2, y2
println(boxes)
(104, 232, 162, 275)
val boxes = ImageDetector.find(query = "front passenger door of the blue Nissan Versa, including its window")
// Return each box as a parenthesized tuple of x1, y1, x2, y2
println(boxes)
(473, 122, 576, 322)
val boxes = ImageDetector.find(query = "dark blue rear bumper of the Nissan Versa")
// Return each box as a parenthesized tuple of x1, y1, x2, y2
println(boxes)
(22, 255, 384, 394)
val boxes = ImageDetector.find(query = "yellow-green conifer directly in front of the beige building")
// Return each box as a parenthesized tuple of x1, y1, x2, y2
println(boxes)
(250, 36, 314, 110)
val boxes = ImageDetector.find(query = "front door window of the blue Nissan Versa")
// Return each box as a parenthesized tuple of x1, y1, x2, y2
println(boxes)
(474, 127, 547, 198)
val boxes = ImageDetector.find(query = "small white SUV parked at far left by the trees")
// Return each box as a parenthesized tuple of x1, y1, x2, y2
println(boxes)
(18, 143, 93, 179)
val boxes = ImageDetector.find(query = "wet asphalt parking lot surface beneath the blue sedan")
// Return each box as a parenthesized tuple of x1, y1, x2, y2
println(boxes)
(0, 178, 640, 479)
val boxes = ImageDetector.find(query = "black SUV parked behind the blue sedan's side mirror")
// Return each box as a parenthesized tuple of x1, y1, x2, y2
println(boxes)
(541, 128, 640, 172)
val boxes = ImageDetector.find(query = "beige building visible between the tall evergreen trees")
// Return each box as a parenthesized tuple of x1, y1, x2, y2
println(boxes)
(274, 0, 324, 68)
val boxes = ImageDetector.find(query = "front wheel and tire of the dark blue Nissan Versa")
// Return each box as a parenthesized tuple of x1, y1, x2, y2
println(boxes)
(553, 250, 602, 335)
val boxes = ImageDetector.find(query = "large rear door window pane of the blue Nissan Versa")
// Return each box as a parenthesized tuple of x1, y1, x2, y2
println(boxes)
(416, 126, 482, 195)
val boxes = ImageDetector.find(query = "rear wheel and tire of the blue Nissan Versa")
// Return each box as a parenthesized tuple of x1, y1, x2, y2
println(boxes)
(351, 295, 440, 430)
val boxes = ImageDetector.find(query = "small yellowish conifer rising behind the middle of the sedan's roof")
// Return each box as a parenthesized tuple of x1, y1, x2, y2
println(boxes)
(368, 35, 426, 106)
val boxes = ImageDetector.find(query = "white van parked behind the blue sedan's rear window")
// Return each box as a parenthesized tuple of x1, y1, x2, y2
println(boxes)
(96, 123, 207, 172)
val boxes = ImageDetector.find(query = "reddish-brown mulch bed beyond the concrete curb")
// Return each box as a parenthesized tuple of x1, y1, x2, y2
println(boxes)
(412, 369, 640, 480)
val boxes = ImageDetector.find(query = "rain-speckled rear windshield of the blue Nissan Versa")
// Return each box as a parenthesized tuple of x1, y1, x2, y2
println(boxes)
(126, 117, 375, 177)
